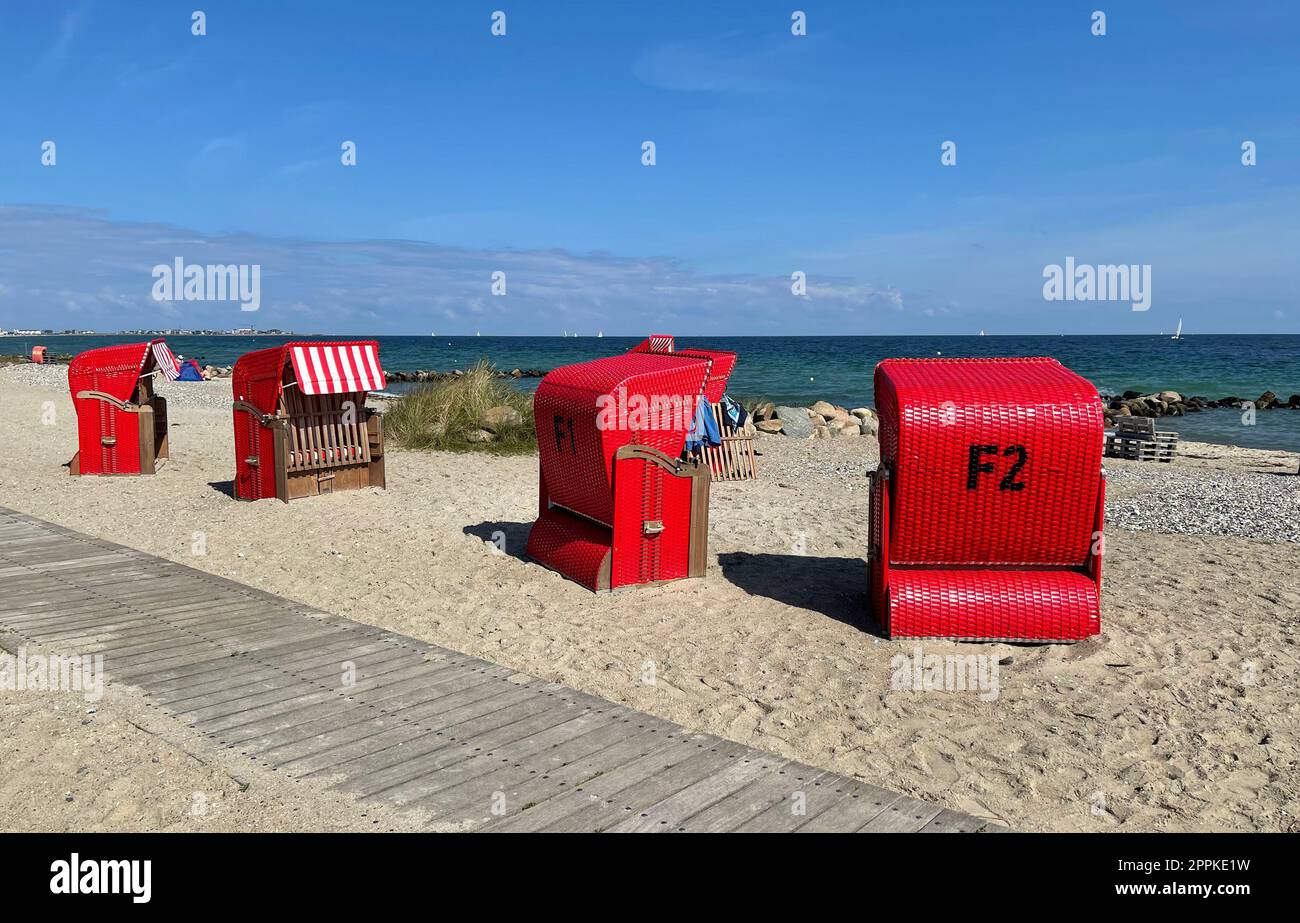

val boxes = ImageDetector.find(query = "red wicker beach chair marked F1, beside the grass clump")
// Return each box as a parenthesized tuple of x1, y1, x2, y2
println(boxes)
(528, 335, 736, 590)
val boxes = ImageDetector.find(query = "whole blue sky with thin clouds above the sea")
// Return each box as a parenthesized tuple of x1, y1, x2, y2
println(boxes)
(0, 0, 1300, 335)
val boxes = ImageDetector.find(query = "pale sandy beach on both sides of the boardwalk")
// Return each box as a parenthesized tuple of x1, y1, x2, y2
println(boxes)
(0, 367, 1300, 831)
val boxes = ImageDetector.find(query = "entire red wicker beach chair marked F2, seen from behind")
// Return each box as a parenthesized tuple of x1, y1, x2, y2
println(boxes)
(870, 359, 1105, 641)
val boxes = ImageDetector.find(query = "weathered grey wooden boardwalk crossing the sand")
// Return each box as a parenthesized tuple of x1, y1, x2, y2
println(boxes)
(0, 507, 1001, 832)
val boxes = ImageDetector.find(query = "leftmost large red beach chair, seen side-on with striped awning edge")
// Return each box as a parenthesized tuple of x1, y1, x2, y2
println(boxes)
(68, 339, 181, 475)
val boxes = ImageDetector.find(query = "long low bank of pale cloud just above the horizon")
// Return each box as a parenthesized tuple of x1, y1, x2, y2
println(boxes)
(0, 205, 902, 334)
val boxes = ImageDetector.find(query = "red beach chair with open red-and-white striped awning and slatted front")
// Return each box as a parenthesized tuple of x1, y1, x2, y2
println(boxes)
(231, 341, 386, 503)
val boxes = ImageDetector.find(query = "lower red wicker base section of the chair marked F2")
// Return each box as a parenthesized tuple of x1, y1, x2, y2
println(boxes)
(883, 567, 1101, 641)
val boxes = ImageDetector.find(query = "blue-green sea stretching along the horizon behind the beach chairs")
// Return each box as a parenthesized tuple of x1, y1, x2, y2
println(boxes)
(10, 334, 1300, 451)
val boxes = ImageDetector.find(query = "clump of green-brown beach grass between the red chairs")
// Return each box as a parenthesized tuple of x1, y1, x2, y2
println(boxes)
(384, 360, 537, 455)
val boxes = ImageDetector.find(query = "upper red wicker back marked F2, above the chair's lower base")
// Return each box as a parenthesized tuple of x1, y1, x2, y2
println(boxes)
(876, 359, 1102, 567)
